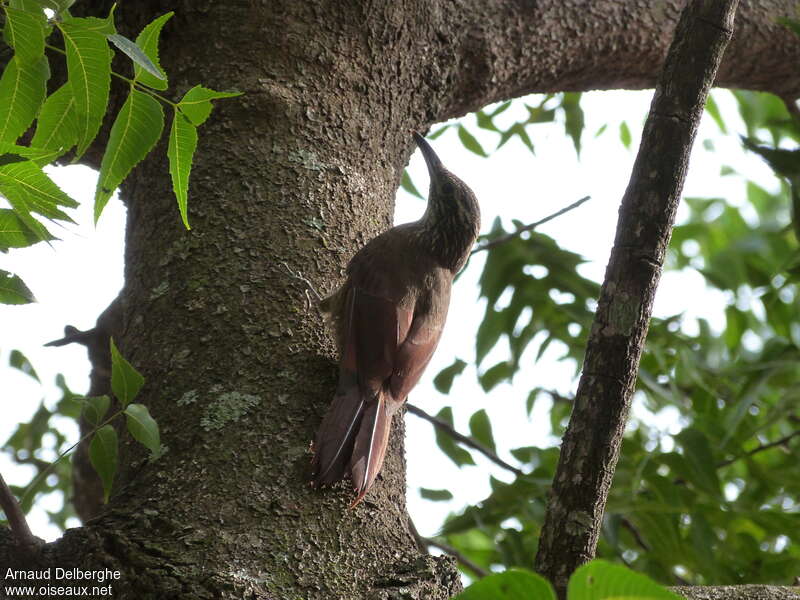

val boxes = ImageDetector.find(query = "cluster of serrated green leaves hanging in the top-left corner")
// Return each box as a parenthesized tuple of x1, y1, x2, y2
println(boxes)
(0, 0, 239, 303)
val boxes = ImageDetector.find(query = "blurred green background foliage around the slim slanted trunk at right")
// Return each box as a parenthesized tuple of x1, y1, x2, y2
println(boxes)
(418, 92, 800, 584)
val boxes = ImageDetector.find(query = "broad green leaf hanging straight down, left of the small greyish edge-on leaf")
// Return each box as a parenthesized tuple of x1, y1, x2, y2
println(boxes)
(59, 18, 114, 160)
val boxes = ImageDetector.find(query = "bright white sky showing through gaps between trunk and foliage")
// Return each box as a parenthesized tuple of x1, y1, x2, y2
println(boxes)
(0, 91, 778, 540)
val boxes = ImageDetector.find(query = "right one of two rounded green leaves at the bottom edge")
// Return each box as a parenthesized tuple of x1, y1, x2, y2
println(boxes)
(567, 560, 681, 600)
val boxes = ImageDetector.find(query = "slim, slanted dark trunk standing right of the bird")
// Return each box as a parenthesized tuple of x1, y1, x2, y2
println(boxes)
(535, 0, 738, 598)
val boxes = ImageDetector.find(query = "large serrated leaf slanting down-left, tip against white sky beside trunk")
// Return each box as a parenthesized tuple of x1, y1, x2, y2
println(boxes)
(94, 87, 164, 223)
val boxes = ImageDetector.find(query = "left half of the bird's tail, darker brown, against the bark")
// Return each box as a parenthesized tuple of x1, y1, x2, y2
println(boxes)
(311, 371, 364, 487)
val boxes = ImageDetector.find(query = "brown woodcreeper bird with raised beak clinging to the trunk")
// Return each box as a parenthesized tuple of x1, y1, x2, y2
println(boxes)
(311, 132, 480, 508)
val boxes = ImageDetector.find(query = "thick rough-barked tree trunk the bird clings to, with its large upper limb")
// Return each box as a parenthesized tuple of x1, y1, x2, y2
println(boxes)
(0, 0, 800, 600)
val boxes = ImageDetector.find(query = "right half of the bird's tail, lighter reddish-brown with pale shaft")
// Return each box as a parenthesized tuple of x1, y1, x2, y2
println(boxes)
(350, 391, 392, 508)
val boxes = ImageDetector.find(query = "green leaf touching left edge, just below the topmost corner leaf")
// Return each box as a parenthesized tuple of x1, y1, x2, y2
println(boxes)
(0, 56, 50, 142)
